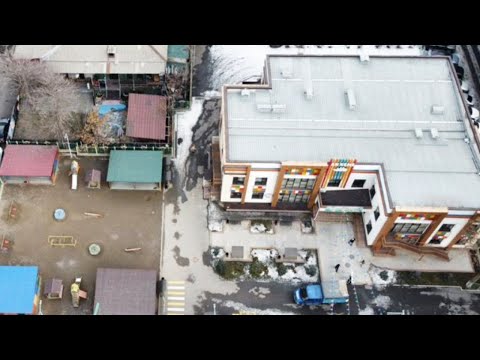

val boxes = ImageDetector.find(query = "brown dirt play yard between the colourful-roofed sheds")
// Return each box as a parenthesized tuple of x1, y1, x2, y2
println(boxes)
(0, 156, 162, 315)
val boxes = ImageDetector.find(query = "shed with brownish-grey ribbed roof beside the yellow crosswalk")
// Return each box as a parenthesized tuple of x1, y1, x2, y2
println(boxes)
(94, 268, 157, 315)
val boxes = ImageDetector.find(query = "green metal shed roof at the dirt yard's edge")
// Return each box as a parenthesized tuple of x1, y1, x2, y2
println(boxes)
(107, 150, 163, 183)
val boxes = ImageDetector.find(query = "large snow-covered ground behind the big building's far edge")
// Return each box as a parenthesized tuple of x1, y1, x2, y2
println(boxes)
(210, 45, 423, 90)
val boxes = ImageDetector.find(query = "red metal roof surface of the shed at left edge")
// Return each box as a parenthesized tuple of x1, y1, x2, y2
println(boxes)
(0, 145, 58, 177)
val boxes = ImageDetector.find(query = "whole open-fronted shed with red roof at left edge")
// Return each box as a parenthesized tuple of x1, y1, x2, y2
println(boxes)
(0, 145, 59, 185)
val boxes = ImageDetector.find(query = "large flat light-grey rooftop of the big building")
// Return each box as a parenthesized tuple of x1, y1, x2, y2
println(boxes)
(226, 56, 480, 208)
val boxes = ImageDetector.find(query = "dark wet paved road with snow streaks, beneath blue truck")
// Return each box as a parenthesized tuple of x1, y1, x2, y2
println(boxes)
(194, 281, 480, 315)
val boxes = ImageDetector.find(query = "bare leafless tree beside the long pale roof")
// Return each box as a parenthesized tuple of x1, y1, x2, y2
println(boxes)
(0, 53, 79, 139)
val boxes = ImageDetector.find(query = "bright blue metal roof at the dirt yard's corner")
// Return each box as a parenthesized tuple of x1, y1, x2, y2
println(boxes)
(0, 266, 38, 314)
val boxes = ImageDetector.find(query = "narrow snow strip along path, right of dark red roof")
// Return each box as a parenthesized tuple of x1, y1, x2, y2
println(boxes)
(174, 98, 204, 181)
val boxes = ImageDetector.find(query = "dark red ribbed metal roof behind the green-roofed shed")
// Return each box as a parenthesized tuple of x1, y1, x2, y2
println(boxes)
(127, 94, 167, 140)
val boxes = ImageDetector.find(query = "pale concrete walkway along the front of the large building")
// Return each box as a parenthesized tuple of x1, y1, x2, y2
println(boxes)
(211, 221, 474, 285)
